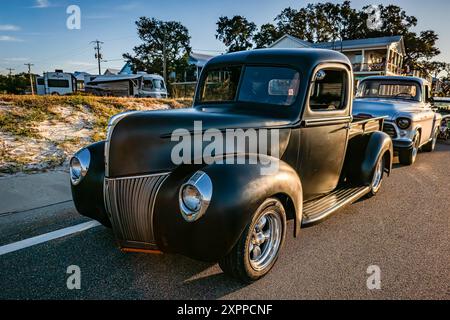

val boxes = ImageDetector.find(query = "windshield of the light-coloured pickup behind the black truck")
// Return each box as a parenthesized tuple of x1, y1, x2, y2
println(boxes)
(356, 80, 422, 101)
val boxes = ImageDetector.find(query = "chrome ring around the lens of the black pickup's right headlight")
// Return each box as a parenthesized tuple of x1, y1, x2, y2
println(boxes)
(178, 171, 213, 222)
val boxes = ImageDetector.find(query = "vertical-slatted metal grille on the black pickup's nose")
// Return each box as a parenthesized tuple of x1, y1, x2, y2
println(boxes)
(104, 173, 169, 250)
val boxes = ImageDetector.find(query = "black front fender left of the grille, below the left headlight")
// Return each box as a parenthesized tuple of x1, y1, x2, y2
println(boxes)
(72, 141, 111, 227)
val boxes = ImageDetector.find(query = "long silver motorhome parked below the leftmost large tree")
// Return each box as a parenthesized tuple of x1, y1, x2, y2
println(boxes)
(85, 72, 167, 98)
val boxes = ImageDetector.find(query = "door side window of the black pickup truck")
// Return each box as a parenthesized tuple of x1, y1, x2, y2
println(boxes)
(309, 68, 348, 111)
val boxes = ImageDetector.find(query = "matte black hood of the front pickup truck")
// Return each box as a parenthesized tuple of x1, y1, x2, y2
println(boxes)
(106, 108, 290, 178)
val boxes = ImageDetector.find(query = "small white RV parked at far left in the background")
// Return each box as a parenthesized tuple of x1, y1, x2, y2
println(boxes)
(36, 70, 77, 96)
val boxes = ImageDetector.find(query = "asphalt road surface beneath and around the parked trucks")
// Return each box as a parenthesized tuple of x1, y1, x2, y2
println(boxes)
(0, 144, 450, 299)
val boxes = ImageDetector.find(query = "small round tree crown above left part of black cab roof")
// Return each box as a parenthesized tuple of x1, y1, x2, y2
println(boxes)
(216, 16, 256, 52)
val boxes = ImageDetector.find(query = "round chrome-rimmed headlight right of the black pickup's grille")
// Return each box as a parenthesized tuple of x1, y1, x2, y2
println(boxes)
(179, 171, 213, 222)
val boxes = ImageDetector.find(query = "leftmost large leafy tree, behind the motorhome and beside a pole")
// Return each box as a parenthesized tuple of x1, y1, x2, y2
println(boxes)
(123, 17, 191, 80)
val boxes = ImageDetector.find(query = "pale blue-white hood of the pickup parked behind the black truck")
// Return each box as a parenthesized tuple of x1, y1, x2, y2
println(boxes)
(353, 98, 423, 121)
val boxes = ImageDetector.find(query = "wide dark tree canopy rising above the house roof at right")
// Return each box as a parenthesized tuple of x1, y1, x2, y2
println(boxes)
(253, 1, 440, 71)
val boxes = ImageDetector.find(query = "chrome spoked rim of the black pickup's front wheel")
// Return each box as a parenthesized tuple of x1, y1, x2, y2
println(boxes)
(248, 211, 283, 271)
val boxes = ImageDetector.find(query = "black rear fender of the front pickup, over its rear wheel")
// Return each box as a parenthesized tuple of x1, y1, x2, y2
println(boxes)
(341, 131, 394, 185)
